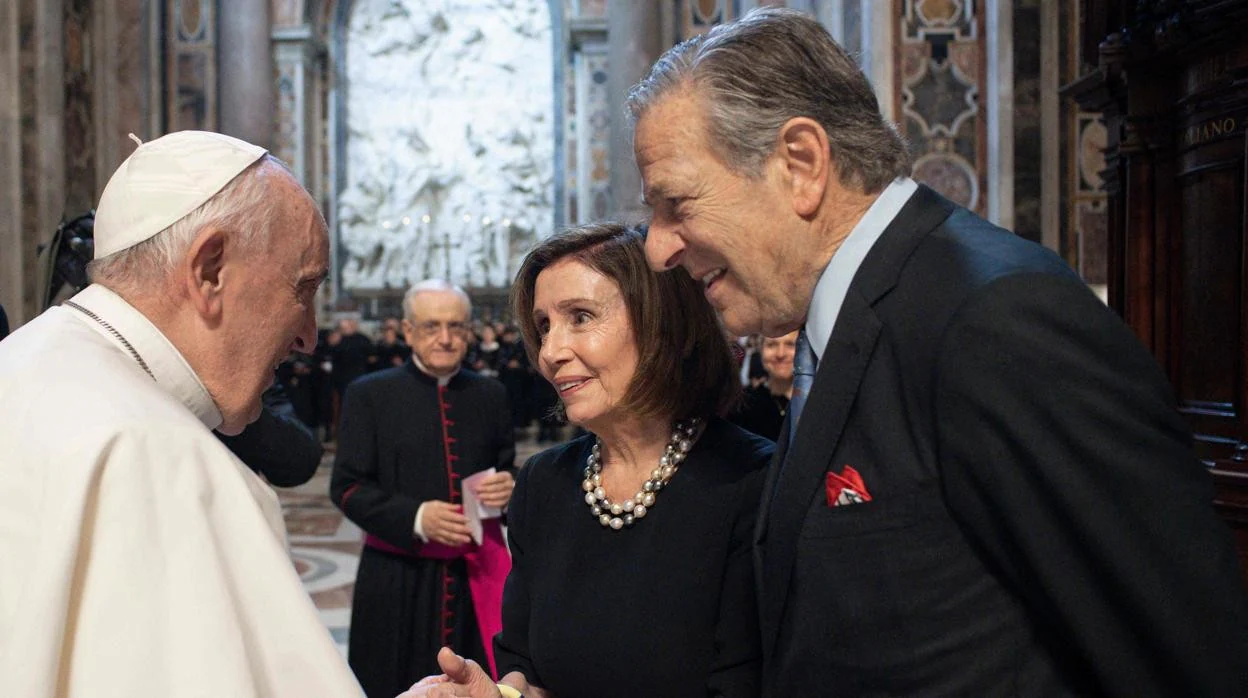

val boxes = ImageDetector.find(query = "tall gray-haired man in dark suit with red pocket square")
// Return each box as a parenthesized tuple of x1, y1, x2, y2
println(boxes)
(628, 9, 1248, 697)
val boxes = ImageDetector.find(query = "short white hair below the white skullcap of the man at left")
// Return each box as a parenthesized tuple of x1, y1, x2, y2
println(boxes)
(86, 154, 290, 292)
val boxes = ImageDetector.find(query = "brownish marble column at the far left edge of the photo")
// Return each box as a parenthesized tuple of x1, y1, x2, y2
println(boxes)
(0, 0, 65, 326)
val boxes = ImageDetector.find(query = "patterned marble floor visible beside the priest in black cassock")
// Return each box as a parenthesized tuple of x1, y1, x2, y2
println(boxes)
(277, 438, 548, 657)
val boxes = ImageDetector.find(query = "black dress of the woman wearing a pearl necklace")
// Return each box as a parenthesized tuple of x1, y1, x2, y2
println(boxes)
(495, 418, 773, 698)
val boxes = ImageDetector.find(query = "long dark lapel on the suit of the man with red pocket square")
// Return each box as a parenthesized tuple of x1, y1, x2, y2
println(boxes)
(754, 185, 957, 656)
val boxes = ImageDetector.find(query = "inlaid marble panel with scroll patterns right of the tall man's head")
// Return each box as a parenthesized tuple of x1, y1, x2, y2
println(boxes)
(895, 0, 987, 215)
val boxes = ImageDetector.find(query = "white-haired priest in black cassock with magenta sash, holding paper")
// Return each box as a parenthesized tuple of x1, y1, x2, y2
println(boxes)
(329, 280, 515, 698)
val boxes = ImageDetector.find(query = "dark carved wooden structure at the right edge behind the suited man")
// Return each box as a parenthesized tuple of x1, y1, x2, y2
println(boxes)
(1065, 0, 1248, 579)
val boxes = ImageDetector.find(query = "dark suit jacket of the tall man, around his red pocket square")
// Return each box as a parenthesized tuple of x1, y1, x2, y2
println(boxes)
(755, 187, 1248, 698)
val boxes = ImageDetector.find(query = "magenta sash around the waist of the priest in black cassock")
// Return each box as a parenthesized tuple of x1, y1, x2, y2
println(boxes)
(364, 518, 512, 681)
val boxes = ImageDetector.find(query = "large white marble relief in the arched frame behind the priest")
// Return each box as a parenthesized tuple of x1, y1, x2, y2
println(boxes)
(337, 0, 554, 292)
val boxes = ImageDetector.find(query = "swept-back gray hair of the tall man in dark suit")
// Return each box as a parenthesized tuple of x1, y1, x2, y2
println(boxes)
(626, 7, 911, 194)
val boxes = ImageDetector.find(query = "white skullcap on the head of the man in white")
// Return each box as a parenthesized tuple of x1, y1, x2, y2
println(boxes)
(95, 131, 268, 260)
